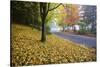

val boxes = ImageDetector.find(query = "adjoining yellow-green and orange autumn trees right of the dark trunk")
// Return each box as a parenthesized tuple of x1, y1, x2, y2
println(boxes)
(47, 4, 79, 31)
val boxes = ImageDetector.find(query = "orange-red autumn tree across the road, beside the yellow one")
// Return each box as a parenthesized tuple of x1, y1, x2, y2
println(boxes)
(63, 4, 79, 31)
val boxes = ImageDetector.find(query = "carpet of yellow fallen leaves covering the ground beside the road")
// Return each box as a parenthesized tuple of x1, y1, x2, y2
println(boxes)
(11, 24, 96, 66)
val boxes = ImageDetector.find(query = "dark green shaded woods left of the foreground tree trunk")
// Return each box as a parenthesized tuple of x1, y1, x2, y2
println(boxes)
(11, 1, 41, 26)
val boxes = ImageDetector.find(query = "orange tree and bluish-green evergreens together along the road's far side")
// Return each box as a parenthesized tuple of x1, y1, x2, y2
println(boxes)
(58, 4, 96, 34)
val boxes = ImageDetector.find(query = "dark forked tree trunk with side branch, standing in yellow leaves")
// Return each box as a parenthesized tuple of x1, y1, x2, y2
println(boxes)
(39, 2, 61, 42)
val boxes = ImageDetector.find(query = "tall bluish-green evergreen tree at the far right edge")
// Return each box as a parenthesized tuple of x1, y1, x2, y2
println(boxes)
(82, 5, 96, 32)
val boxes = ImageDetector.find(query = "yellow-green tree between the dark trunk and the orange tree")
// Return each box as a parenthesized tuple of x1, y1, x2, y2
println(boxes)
(46, 4, 67, 30)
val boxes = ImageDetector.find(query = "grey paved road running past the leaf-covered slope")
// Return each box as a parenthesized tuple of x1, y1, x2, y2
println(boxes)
(54, 32, 96, 48)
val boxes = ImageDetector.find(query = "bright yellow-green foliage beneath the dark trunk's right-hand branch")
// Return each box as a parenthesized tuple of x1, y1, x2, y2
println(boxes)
(46, 3, 66, 24)
